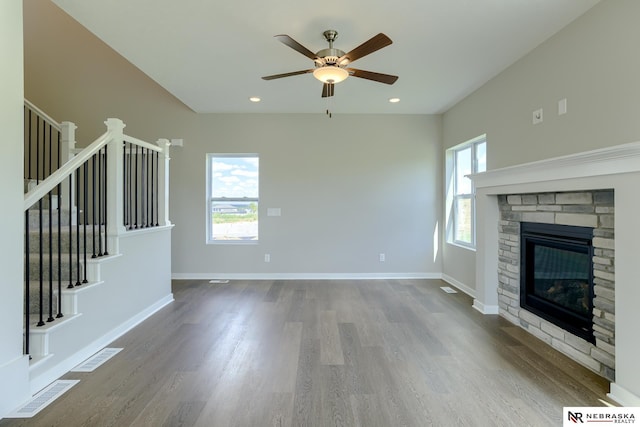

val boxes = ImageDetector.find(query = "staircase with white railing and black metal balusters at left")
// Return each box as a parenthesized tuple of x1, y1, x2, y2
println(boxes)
(24, 103, 173, 392)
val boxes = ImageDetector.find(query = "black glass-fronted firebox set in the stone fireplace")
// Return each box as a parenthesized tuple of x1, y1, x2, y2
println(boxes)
(520, 222, 595, 343)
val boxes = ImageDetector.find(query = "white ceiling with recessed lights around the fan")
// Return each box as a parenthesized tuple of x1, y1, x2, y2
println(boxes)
(53, 0, 598, 114)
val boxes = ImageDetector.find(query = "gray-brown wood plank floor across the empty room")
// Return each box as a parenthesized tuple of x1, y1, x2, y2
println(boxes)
(0, 280, 608, 427)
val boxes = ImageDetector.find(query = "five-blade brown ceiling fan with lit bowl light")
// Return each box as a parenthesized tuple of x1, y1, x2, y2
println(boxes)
(263, 30, 398, 98)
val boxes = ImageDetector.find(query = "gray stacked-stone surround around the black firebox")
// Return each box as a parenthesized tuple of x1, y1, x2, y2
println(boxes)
(498, 190, 615, 381)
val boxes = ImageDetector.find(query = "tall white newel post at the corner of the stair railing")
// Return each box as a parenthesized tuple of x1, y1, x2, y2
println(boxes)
(104, 118, 126, 255)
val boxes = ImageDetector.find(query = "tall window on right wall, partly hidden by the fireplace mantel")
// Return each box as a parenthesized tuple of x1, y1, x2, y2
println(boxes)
(448, 135, 487, 247)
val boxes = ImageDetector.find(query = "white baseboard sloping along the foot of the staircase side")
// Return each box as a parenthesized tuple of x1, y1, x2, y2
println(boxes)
(30, 294, 173, 395)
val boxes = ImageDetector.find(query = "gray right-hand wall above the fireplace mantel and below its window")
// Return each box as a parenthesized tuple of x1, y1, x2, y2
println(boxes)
(443, 0, 640, 288)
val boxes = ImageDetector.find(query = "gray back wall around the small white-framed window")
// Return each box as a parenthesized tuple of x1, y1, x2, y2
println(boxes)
(171, 114, 441, 277)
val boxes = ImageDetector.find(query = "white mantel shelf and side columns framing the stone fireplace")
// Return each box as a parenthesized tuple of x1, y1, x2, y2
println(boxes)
(471, 143, 640, 406)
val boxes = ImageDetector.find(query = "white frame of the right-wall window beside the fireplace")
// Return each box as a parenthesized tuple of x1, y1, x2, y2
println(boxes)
(447, 135, 487, 249)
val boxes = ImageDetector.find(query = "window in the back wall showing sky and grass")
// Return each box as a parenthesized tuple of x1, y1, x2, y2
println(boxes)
(207, 154, 259, 243)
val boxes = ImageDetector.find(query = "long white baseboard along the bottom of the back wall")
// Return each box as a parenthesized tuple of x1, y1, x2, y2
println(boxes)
(171, 273, 442, 280)
